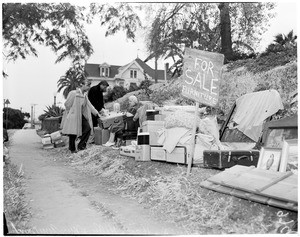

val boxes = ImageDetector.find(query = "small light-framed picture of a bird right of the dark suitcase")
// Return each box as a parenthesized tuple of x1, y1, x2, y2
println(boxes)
(257, 147, 281, 171)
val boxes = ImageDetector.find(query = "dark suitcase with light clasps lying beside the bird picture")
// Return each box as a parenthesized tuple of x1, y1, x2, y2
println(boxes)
(203, 150, 259, 169)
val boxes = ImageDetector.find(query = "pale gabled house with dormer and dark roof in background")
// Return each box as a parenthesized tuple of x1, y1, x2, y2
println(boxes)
(85, 58, 165, 88)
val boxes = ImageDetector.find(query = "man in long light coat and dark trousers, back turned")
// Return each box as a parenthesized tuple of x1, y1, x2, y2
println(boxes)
(61, 80, 100, 153)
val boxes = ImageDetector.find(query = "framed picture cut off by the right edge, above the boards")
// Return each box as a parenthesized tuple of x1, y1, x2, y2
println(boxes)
(279, 139, 298, 173)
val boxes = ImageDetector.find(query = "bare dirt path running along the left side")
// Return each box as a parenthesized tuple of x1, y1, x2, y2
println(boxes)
(10, 129, 185, 234)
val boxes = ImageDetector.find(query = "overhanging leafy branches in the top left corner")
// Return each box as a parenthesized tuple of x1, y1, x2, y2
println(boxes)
(2, 3, 93, 63)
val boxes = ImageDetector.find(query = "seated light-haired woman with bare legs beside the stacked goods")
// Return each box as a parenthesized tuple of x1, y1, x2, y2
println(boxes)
(103, 95, 139, 147)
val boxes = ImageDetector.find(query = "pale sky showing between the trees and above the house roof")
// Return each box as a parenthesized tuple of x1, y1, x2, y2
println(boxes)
(2, 1, 299, 119)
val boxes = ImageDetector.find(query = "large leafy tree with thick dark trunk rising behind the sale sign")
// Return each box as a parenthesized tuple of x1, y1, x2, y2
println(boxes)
(144, 3, 274, 72)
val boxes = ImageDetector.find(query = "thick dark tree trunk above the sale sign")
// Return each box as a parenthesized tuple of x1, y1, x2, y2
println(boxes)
(218, 2, 233, 61)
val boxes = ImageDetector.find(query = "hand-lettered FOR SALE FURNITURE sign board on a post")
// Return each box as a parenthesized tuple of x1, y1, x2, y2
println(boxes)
(182, 48, 224, 107)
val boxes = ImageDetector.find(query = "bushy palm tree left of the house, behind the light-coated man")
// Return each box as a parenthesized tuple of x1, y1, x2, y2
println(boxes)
(57, 62, 87, 98)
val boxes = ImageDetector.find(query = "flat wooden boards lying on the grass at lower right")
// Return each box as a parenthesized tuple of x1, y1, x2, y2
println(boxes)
(203, 165, 298, 210)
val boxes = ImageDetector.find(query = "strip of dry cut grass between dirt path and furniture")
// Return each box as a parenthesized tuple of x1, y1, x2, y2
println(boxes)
(49, 146, 296, 234)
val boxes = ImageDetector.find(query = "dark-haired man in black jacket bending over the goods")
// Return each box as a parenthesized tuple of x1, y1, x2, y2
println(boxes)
(88, 80, 109, 127)
